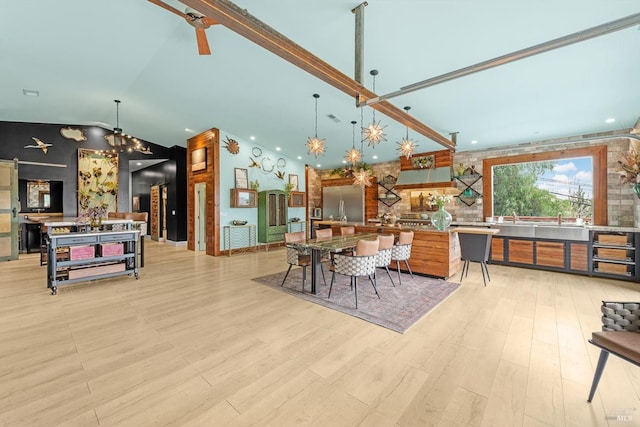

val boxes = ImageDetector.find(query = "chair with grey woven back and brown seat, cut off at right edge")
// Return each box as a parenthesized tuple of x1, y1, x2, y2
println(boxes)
(587, 301, 640, 402)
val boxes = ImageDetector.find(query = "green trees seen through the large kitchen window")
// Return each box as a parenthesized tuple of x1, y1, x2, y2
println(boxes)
(493, 161, 593, 218)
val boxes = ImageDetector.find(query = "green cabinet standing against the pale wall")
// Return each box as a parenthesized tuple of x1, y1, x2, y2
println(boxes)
(258, 190, 287, 243)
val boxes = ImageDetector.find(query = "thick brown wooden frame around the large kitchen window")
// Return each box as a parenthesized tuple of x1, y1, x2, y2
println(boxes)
(482, 145, 608, 225)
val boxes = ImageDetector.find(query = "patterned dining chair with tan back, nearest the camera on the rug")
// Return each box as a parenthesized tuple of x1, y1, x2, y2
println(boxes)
(327, 239, 380, 309)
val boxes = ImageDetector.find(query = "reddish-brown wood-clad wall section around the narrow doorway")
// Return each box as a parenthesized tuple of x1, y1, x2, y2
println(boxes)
(187, 128, 220, 256)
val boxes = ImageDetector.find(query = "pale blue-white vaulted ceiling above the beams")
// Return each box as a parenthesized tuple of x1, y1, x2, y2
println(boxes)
(0, 0, 640, 168)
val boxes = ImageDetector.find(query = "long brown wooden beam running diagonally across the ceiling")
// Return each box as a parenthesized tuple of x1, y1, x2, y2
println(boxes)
(181, 0, 456, 150)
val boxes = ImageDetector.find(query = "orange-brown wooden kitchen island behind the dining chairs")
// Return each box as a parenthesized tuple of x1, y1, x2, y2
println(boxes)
(356, 225, 462, 278)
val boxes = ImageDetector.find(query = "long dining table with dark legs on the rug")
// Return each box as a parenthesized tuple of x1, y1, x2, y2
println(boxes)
(288, 233, 378, 294)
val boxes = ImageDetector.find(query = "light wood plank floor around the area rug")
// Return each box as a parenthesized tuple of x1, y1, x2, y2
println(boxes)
(0, 242, 640, 427)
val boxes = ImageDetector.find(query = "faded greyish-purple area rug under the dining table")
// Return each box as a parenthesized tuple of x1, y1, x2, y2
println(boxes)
(253, 267, 460, 333)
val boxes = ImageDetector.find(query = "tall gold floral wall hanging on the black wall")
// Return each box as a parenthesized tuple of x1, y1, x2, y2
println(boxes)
(78, 149, 118, 216)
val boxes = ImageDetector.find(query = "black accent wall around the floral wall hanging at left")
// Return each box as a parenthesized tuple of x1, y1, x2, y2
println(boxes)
(0, 121, 187, 241)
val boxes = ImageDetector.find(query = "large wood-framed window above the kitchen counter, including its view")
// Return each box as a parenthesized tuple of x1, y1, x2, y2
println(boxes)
(483, 146, 607, 225)
